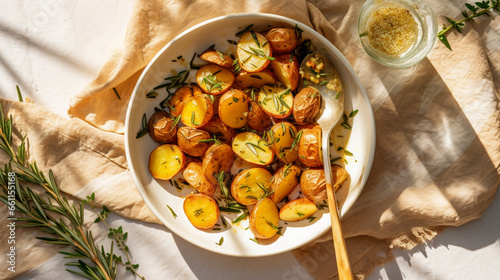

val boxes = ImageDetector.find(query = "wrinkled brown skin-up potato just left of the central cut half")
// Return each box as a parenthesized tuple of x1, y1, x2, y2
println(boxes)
(203, 143, 234, 184)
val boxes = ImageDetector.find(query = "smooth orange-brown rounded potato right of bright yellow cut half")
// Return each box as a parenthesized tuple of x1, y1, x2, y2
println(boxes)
(219, 89, 248, 128)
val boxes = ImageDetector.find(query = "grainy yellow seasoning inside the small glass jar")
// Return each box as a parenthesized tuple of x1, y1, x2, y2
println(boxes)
(364, 2, 419, 56)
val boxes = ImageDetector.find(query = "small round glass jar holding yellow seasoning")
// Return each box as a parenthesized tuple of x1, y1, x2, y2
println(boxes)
(358, 0, 437, 68)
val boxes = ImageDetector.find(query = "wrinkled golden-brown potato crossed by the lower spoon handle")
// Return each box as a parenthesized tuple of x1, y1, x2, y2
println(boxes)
(300, 165, 349, 204)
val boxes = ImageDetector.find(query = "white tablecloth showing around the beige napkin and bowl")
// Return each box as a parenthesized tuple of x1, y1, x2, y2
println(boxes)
(0, 0, 500, 280)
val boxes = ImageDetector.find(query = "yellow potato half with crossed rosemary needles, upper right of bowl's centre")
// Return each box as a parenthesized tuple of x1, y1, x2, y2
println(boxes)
(258, 83, 293, 119)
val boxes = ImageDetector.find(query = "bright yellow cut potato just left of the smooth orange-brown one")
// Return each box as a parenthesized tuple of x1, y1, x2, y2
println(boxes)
(181, 94, 214, 127)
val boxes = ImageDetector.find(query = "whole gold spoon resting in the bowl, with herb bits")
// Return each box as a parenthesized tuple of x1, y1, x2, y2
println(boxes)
(300, 52, 353, 280)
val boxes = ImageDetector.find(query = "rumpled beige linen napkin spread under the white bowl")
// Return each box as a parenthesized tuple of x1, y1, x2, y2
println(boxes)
(0, 0, 500, 279)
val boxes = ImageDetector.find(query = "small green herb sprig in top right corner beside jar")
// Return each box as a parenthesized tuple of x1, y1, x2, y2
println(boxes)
(437, 0, 500, 51)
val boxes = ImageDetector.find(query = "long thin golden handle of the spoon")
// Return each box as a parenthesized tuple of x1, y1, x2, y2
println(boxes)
(322, 131, 353, 280)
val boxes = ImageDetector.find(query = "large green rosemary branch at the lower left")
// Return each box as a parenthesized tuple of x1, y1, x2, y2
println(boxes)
(0, 99, 144, 279)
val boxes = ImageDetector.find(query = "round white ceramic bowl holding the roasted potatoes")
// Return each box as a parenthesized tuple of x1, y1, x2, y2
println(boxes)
(125, 14, 375, 257)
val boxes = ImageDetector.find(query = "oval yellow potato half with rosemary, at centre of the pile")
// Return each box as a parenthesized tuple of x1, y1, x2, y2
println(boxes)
(232, 131, 274, 165)
